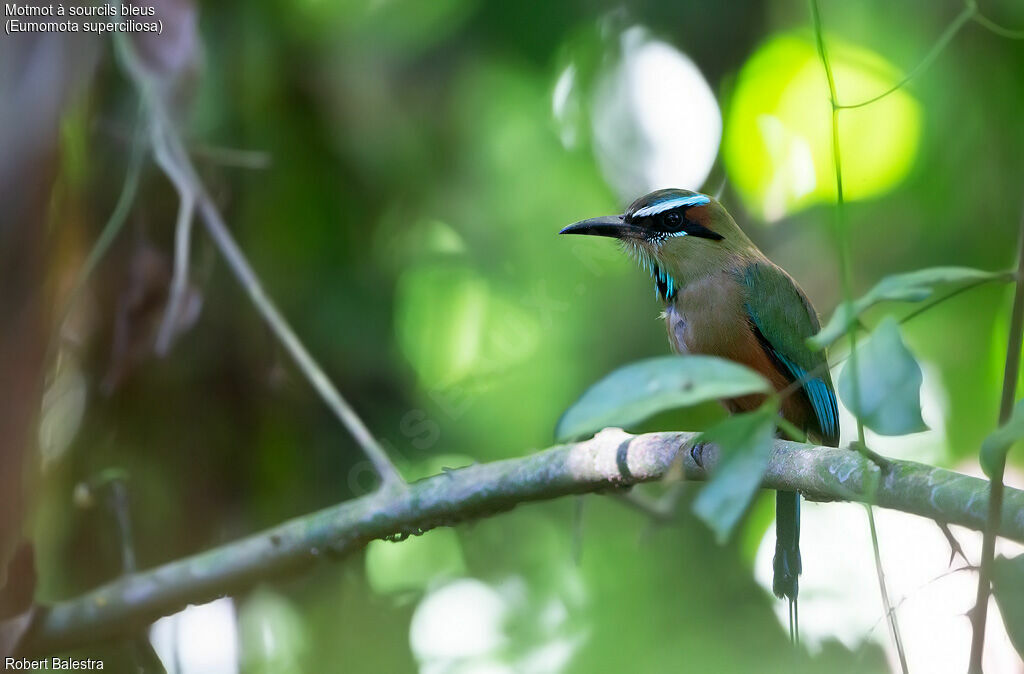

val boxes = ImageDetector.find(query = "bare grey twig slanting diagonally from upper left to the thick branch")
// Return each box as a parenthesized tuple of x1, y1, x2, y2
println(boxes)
(114, 33, 404, 487)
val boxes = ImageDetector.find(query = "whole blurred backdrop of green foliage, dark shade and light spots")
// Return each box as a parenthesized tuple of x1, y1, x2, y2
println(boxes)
(6, 0, 1024, 674)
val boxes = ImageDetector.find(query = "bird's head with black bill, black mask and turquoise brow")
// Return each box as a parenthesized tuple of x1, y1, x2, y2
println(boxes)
(559, 185, 753, 301)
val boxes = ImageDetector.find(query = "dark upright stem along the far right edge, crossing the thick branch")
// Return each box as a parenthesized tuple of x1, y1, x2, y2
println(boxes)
(968, 196, 1024, 674)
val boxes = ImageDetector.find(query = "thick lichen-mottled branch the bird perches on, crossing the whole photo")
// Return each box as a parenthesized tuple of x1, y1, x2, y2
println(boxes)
(14, 429, 1024, 654)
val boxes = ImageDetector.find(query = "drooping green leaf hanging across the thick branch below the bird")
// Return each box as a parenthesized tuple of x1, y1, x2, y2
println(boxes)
(693, 403, 778, 543)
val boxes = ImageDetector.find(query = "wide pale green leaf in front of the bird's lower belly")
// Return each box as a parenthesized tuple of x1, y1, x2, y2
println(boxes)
(555, 355, 771, 443)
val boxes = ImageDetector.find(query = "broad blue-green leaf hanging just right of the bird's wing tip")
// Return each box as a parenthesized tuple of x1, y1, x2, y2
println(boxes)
(839, 315, 928, 435)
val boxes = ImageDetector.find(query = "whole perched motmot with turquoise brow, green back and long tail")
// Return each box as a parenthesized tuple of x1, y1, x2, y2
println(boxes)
(559, 188, 840, 641)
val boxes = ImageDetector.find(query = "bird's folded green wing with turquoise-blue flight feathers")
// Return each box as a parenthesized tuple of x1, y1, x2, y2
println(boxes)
(741, 262, 839, 447)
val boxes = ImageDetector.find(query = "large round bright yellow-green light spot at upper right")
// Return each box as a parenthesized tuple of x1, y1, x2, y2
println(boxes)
(723, 35, 921, 221)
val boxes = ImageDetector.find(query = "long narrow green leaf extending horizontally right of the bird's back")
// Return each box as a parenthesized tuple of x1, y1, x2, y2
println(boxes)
(807, 266, 1011, 349)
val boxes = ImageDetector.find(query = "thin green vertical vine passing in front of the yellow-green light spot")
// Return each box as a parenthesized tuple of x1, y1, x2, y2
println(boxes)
(810, 0, 908, 674)
